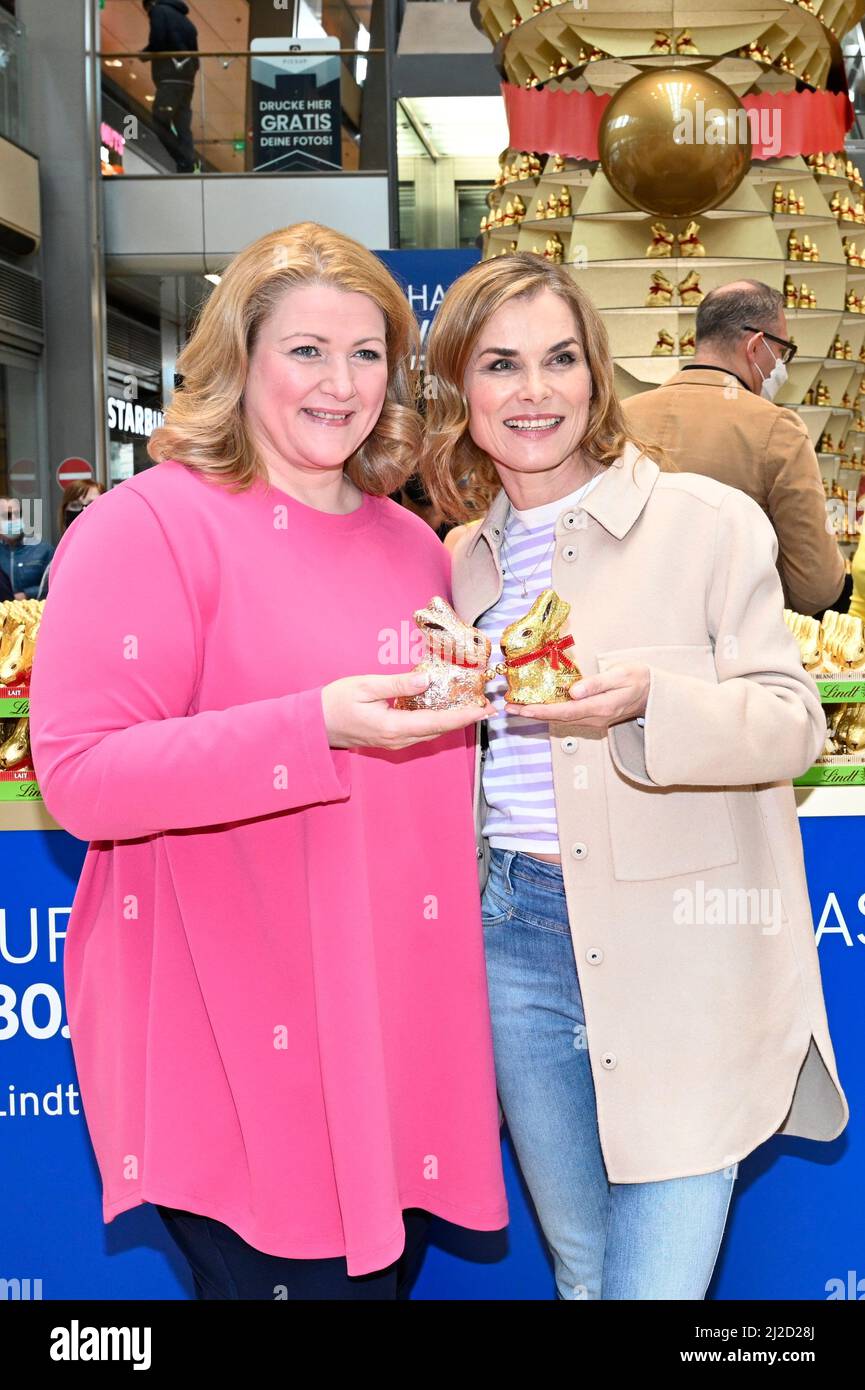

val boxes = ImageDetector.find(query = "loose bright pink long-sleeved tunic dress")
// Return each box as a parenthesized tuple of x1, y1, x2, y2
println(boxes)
(31, 463, 508, 1275)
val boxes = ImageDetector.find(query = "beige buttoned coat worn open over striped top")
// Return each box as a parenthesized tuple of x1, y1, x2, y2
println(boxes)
(453, 443, 848, 1183)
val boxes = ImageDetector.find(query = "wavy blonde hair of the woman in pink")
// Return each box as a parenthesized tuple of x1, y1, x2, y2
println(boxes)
(147, 222, 420, 496)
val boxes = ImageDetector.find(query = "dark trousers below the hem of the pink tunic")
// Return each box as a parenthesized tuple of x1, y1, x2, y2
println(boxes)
(156, 1205, 430, 1302)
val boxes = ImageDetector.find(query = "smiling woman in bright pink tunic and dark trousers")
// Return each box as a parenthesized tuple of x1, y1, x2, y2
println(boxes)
(31, 224, 508, 1298)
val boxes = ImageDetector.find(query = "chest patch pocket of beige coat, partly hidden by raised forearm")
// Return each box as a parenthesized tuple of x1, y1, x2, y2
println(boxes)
(598, 644, 738, 881)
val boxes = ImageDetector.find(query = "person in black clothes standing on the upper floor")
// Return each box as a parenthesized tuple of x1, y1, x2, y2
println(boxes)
(142, 0, 199, 174)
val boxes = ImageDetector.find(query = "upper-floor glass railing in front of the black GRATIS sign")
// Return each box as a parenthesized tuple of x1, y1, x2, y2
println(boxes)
(100, 47, 385, 175)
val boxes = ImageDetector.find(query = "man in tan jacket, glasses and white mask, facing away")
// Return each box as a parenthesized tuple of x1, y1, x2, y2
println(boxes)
(623, 279, 844, 613)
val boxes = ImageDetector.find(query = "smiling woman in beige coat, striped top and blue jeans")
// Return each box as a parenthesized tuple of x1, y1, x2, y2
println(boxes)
(424, 254, 848, 1298)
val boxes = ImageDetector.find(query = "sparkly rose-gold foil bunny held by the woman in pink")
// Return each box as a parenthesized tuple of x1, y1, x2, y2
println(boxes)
(394, 595, 494, 709)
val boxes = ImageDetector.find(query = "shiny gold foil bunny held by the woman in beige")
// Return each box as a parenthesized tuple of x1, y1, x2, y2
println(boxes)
(495, 589, 583, 705)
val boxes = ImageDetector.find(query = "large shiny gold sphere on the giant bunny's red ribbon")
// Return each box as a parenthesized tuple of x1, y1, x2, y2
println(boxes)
(598, 67, 751, 217)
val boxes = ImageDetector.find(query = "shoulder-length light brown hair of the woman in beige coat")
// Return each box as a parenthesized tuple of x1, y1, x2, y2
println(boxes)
(421, 252, 670, 521)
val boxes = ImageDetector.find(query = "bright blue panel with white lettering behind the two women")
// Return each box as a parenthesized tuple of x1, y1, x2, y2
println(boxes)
(0, 811, 865, 1300)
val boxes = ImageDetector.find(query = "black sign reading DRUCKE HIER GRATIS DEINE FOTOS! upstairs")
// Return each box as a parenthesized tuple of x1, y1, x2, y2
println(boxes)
(250, 38, 342, 172)
